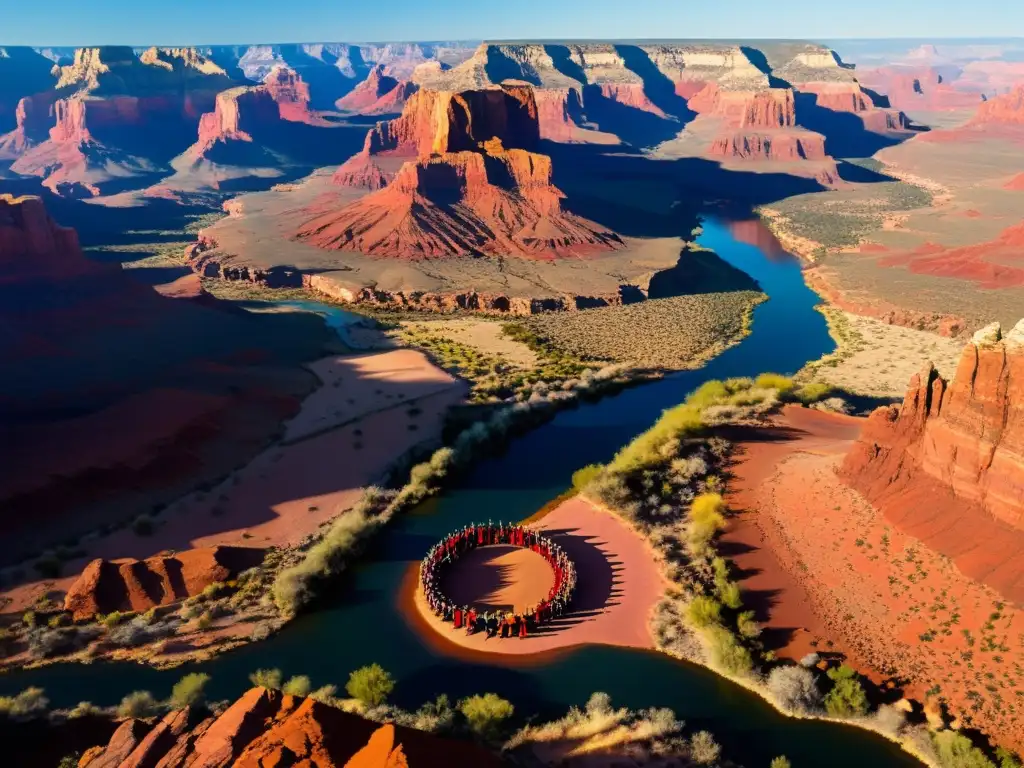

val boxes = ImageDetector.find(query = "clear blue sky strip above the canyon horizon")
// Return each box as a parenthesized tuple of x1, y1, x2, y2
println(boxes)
(0, 0, 1024, 45)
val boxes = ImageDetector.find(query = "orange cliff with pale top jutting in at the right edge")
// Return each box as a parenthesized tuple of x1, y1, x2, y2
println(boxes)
(840, 321, 1024, 530)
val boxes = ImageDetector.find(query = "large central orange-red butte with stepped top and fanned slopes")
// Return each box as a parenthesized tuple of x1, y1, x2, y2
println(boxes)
(296, 86, 624, 259)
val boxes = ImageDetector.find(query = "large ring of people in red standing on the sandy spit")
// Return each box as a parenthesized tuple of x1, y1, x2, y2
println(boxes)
(420, 522, 577, 638)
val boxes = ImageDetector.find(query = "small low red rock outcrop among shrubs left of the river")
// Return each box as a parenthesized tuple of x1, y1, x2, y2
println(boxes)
(65, 547, 263, 621)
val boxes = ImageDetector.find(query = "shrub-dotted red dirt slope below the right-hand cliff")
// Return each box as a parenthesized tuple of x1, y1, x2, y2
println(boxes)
(725, 408, 1024, 749)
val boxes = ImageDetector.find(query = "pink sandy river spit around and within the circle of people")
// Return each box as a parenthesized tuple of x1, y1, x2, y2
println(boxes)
(401, 497, 667, 656)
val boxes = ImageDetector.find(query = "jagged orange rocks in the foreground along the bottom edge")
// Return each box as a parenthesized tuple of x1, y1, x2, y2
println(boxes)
(78, 688, 502, 768)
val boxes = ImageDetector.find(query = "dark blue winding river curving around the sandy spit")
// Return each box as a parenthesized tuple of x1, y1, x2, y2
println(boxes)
(0, 219, 919, 768)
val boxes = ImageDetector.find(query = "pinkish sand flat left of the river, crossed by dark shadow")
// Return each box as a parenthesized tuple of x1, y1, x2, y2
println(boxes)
(2, 349, 466, 612)
